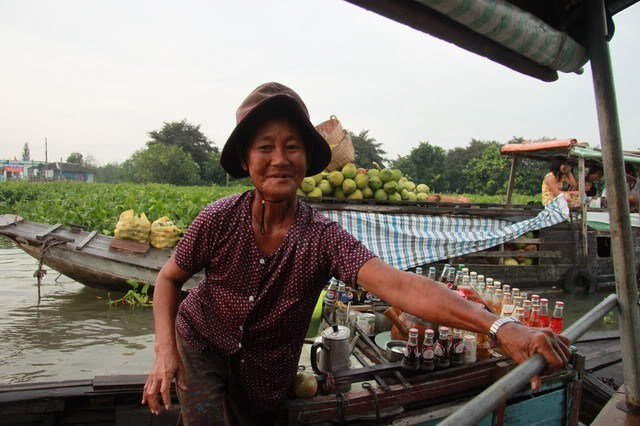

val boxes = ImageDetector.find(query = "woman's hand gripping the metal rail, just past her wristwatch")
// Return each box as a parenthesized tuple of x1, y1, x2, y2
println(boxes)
(497, 323, 571, 392)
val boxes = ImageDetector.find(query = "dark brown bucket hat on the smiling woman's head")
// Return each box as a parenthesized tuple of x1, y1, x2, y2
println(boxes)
(220, 82, 331, 178)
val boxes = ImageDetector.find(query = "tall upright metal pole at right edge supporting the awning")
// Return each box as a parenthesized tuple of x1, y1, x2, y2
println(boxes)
(585, 0, 640, 412)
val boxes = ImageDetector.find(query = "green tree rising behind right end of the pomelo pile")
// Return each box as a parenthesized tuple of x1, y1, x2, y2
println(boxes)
(392, 142, 449, 192)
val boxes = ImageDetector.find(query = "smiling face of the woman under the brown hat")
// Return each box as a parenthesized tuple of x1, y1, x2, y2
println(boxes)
(242, 120, 307, 201)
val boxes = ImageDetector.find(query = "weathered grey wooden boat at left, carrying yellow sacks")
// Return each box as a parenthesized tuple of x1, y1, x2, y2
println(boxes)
(0, 215, 201, 291)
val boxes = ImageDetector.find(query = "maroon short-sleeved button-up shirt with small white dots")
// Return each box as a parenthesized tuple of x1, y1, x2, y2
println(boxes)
(175, 191, 375, 413)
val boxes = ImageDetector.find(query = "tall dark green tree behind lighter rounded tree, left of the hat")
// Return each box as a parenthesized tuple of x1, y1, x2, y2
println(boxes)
(147, 119, 218, 180)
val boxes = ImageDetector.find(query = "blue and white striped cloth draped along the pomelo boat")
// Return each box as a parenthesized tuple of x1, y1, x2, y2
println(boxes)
(322, 196, 569, 270)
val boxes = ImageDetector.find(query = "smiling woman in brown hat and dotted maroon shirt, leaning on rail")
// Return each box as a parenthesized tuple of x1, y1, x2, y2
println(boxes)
(143, 83, 569, 425)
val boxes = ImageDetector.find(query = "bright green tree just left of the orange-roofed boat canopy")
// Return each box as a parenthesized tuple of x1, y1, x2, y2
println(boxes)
(467, 144, 509, 195)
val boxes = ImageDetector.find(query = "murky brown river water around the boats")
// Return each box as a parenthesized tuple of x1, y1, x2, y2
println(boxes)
(0, 237, 617, 384)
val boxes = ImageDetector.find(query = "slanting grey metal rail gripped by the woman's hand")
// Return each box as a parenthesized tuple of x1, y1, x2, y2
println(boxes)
(439, 294, 617, 426)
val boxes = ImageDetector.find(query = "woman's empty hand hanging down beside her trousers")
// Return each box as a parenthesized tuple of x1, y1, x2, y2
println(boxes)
(142, 348, 187, 414)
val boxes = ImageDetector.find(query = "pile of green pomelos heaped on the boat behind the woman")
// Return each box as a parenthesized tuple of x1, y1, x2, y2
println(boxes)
(298, 163, 430, 201)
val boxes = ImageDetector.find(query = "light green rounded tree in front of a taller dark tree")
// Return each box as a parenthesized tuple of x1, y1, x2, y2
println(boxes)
(125, 144, 200, 185)
